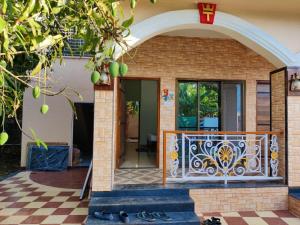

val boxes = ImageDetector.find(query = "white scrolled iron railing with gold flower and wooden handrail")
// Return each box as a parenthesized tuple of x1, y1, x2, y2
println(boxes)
(163, 131, 281, 183)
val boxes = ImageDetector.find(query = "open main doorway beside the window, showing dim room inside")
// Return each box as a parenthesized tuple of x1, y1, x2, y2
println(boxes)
(116, 79, 159, 168)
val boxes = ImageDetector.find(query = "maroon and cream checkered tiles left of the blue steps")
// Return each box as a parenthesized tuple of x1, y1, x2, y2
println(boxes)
(0, 172, 88, 225)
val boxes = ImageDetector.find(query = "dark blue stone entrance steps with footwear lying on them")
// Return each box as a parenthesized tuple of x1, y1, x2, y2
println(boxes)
(86, 188, 200, 225)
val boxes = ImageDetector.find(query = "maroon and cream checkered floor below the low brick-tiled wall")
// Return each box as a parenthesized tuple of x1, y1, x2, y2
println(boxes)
(201, 211, 300, 225)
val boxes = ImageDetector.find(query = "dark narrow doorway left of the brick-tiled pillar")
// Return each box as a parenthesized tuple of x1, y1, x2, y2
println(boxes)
(72, 103, 94, 166)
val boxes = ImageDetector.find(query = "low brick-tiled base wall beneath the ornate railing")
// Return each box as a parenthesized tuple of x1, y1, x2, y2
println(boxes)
(190, 187, 288, 214)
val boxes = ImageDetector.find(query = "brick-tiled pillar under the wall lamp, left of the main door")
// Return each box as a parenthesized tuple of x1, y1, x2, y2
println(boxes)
(92, 90, 114, 191)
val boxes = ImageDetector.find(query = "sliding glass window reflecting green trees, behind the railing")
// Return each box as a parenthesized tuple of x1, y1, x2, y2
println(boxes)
(176, 81, 243, 131)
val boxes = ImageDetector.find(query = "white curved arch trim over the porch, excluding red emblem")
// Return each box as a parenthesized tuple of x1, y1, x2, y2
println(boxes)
(116, 10, 300, 67)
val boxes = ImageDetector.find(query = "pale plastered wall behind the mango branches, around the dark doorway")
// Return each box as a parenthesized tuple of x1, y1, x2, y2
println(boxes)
(21, 58, 94, 166)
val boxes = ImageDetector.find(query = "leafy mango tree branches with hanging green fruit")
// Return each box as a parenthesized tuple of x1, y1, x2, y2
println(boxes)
(0, 0, 155, 147)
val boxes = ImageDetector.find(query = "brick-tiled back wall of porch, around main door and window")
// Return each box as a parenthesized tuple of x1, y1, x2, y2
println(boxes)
(124, 36, 274, 168)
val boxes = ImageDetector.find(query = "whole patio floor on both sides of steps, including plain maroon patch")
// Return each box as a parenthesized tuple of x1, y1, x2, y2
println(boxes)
(0, 169, 300, 225)
